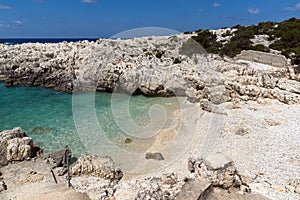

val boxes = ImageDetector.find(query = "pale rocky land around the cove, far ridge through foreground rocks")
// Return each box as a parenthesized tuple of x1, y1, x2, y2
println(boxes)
(0, 30, 300, 199)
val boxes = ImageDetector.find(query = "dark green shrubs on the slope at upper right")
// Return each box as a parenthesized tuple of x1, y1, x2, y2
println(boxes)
(192, 18, 300, 64)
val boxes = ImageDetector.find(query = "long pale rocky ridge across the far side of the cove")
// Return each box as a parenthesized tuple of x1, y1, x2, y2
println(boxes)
(0, 35, 300, 104)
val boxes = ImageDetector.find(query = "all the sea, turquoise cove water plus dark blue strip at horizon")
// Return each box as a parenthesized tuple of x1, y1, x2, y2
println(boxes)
(0, 38, 180, 156)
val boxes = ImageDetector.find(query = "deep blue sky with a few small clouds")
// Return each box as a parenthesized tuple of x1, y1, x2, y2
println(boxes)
(0, 0, 300, 38)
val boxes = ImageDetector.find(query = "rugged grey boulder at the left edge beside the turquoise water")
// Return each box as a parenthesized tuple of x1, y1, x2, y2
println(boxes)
(0, 128, 40, 166)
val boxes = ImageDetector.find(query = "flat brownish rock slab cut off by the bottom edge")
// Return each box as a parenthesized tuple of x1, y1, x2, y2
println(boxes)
(176, 179, 213, 200)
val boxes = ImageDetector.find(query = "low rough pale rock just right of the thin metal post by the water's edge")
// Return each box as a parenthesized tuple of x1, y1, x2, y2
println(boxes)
(71, 156, 123, 182)
